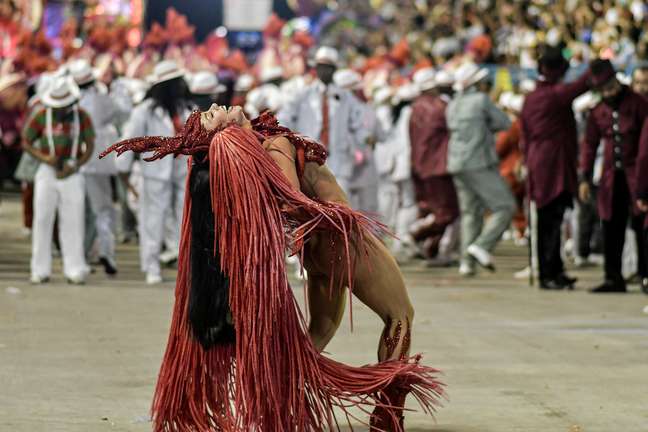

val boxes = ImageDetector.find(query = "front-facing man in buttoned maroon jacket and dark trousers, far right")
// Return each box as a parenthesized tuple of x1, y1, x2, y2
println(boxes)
(579, 60, 648, 293)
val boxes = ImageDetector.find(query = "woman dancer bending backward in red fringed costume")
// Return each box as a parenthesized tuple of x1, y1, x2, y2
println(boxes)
(102, 106, 442, 432)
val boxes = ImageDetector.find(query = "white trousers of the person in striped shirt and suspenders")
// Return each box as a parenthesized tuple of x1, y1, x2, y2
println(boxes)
(31, 164, 87, 279)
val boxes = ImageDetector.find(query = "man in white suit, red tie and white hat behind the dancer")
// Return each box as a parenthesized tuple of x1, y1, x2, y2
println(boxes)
(278, 47, 371, 193)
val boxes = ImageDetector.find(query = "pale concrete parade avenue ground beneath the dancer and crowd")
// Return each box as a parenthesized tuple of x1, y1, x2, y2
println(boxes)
(0, 196, 648, 432)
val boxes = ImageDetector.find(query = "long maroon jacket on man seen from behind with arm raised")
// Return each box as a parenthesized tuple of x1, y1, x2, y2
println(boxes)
(520, 73, 589, 208)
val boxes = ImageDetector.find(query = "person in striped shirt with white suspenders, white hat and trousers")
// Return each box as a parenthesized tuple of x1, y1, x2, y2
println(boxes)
(23, 76, 94, 284)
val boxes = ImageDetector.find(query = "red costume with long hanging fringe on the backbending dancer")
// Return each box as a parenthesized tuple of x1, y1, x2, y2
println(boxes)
(106, 112, 443, 432)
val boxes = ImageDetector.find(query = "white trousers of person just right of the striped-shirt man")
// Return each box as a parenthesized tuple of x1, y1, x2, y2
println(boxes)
(84, 174, 115, 263)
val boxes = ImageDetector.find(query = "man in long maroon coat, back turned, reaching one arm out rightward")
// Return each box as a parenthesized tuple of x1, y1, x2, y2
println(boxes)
(520, 47, 589, 289)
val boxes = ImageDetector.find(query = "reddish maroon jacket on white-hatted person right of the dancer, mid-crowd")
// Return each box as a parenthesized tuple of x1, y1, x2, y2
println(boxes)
(409, 94, 450, 179)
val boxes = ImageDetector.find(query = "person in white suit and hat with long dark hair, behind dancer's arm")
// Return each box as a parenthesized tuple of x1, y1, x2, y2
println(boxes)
(117, 60, 190, 285)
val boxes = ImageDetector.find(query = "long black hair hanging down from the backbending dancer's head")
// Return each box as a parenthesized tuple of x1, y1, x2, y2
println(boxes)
(189, 155, 236, 349)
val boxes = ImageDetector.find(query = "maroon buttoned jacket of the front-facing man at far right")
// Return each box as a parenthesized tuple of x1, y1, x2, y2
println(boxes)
(580, 88, 648, 220)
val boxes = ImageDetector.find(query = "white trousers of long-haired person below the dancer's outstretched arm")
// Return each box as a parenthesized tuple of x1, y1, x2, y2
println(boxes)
(138, 177, 185, 275)
